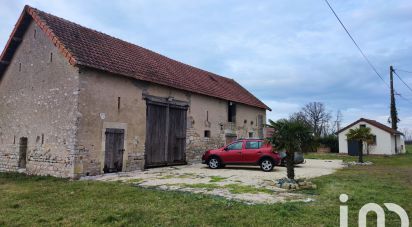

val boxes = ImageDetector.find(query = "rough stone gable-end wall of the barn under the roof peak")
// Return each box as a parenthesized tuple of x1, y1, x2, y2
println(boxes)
(0, 22, 79, 177)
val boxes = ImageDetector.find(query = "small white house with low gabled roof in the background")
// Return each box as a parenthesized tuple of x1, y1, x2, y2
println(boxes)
(337, 118, 406, 156)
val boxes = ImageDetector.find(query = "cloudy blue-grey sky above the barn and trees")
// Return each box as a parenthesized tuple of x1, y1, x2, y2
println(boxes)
(0, 0, 412, 129)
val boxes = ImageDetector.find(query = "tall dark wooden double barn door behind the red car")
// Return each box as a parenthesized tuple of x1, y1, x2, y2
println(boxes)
(145, 99, 187, 167)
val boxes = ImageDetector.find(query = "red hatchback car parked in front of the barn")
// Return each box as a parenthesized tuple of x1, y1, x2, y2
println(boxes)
(202, 139, 281, 172)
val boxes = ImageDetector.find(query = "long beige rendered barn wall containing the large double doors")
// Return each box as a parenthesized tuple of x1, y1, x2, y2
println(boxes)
(75, 69, 265, 175)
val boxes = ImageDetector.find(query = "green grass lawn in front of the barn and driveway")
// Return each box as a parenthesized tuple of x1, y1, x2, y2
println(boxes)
(0, 146, 412, 226)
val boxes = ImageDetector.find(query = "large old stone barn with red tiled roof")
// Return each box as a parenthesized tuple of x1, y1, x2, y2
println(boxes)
(0, 6, 270, 178)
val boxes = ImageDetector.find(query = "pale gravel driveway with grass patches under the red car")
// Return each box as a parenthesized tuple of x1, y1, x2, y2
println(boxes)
(82, 159, 344, 204)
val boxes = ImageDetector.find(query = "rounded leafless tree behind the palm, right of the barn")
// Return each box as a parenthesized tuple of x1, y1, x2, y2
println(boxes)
(293, 102, 332, 137)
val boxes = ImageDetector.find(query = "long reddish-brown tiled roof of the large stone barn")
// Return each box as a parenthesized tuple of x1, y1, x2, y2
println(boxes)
(0, 6, 270, 110)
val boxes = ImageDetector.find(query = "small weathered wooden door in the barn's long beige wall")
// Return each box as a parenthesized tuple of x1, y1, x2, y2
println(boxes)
(103, 128, 124, 173)
